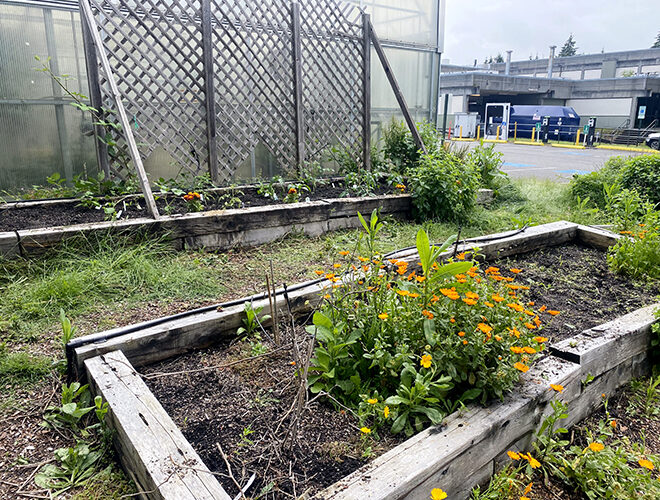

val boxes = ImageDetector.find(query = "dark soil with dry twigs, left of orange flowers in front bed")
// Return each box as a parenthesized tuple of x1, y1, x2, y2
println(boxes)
(143, 329, 403, 498)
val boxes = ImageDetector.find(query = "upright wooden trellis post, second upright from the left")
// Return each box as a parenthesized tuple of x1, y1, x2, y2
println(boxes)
(201, 0, 220, 184)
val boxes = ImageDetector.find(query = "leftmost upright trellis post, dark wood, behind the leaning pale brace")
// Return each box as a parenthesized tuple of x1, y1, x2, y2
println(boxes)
(80, 7, 110, 178)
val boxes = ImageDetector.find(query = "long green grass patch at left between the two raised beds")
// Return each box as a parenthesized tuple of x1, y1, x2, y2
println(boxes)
(0, 234, 223, 342)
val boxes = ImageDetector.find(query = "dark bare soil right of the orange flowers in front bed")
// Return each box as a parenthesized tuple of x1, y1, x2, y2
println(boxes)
(488, 244, 660, 342)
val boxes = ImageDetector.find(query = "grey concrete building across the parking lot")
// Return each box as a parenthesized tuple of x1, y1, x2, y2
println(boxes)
(440, 49, 660, 128)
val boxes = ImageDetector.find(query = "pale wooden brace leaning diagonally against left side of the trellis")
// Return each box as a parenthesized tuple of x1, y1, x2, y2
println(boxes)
(80, 0, 159, 219)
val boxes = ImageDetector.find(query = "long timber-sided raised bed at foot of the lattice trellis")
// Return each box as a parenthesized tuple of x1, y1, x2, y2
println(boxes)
(0, 181, 493, 257)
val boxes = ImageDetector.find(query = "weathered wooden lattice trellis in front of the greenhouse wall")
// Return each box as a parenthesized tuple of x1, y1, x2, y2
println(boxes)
(81, 0, 368, 181)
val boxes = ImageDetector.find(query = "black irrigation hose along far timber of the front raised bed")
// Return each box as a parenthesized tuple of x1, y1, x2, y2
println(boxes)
(65, 225, 527, 381)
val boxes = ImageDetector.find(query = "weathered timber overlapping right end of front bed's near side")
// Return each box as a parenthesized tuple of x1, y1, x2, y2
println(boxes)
(550, 303, 660, 377)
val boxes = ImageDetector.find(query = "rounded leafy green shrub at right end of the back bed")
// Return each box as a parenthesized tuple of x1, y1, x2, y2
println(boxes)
(407, 150, 479, 221)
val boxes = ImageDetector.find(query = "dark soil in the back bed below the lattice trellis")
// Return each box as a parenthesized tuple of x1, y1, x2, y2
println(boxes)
(0, 180, 393, 232)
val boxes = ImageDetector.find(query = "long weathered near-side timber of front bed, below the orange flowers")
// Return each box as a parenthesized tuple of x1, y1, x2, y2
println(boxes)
(315, 360, 579, 500)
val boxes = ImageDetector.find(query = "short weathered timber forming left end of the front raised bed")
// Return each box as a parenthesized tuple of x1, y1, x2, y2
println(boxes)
(85, 351, 230, 500)
